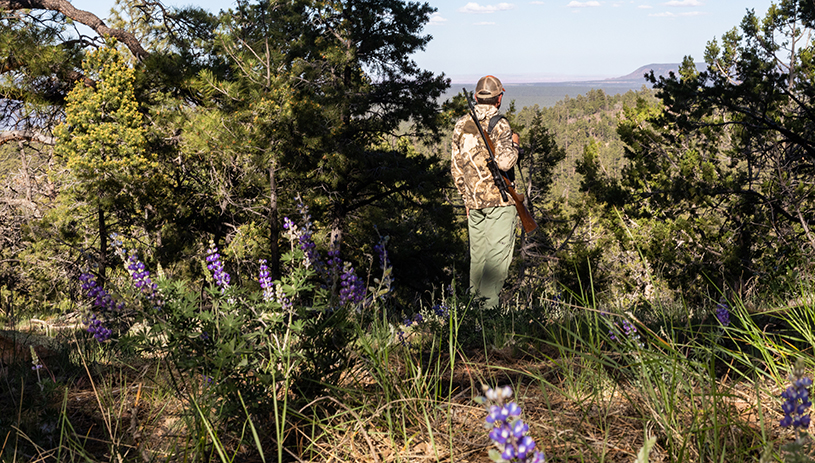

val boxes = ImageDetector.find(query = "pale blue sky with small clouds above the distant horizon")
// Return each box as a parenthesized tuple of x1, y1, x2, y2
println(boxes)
(72, 0, 772, 84)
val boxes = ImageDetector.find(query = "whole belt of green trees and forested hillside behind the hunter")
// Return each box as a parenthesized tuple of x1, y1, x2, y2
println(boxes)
(0, 0, 813, 336)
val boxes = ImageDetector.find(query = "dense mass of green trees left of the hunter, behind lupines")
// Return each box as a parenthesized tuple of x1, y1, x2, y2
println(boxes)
(3, 1, 464, 318)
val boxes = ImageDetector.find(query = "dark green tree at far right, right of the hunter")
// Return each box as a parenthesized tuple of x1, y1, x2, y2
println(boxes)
(583, 1, 815, 306)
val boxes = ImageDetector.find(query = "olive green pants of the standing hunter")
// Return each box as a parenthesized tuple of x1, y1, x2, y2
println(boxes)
(467, 206, 517, 308)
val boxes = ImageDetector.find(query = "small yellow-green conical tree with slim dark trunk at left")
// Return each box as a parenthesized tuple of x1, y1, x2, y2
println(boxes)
(55, 42, 150, 276)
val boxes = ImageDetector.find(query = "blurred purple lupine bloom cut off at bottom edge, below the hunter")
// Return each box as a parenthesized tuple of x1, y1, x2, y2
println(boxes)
(482, 386, 544, 463)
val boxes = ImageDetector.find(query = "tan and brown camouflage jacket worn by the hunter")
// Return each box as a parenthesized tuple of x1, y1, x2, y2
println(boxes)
(450, 105, 518, 209)
